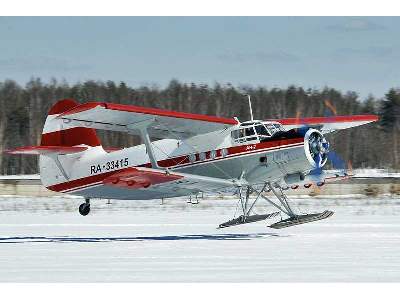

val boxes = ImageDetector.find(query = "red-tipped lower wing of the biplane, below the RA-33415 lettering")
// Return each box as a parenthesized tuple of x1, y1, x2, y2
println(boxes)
(103, 167, 236, 193)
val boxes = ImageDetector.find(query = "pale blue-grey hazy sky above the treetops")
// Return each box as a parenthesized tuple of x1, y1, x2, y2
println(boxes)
(0, 17, 400, 97)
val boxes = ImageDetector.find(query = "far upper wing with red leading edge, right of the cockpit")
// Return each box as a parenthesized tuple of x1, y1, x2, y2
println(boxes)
(271, 115, 378, 133)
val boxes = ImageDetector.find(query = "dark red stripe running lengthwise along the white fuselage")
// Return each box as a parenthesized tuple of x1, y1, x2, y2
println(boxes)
(47, 138, 303, 192)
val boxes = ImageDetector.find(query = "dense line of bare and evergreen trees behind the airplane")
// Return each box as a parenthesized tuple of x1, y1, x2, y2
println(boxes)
(0, 78, 400, 174)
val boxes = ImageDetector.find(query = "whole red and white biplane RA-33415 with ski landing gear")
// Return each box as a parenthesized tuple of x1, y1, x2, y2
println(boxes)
(8, 97, 378, 229)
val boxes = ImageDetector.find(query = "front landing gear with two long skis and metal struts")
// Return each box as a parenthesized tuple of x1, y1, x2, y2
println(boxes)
(219, 182, 333, 229)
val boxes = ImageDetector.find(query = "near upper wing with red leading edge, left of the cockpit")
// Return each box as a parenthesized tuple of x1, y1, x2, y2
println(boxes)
(57, 102, 238, 138)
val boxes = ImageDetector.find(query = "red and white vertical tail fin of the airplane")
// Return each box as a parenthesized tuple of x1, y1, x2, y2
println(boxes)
(40, 99, 101, 147)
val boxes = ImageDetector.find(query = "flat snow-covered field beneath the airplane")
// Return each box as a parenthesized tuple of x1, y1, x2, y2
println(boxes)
(0, 196, 400, 282)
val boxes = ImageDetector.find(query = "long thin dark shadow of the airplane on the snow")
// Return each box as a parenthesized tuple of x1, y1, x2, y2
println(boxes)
(0, 233, 287, 244)
